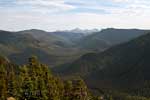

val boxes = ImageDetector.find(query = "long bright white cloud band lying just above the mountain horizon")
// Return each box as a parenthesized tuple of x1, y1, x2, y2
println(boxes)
(0, 13, 150, 31)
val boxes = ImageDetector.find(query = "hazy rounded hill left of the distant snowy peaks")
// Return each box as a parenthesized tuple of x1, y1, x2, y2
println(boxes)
(18, 29, 72, 47)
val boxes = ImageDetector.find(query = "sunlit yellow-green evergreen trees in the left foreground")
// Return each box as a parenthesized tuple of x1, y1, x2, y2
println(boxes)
(0, 56, 103, 100)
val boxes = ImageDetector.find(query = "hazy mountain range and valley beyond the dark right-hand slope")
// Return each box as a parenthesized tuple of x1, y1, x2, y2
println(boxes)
(0, 29, 148, 67)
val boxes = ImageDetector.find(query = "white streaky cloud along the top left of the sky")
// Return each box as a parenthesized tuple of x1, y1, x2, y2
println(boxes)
(1, 0, 75, 13)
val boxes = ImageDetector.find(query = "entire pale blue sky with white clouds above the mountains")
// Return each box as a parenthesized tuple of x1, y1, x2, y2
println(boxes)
(0, 0, 150, 31)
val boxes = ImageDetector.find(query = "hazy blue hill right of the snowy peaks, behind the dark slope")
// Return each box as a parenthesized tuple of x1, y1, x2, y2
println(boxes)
(78, 28, 149, 51)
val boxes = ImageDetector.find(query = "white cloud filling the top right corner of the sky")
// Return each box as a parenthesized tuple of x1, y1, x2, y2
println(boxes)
(105, 0, 150, 16)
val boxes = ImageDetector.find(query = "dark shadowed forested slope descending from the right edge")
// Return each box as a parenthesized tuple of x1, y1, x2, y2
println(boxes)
(54, 33, 150, 88)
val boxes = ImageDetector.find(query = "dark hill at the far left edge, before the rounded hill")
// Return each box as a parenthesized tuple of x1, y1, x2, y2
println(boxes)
(0, 31, 38, 55)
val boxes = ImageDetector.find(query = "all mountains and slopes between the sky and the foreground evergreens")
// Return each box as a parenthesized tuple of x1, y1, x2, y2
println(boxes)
(0, 28, 150, 97)
